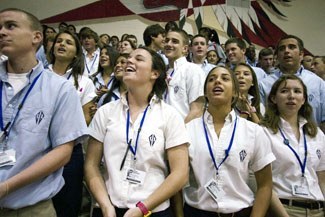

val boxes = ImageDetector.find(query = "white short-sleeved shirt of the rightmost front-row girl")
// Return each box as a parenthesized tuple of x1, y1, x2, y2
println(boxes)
(264, 118, 325, 201)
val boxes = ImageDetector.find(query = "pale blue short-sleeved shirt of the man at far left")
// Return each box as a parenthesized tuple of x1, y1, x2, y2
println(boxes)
(0, 61, 87, 209)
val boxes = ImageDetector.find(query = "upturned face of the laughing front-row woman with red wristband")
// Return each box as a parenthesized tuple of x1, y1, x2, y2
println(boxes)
(123, 48, 157, 88)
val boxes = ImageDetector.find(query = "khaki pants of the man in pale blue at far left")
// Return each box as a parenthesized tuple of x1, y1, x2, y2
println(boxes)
(0, 200, 56, 217)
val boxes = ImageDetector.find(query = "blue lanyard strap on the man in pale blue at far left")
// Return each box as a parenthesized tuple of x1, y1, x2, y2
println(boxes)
(0, 71, 43, 137)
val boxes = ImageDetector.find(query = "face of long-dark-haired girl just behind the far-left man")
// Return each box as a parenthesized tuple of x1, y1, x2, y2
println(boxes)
(53, 33, 77, 62)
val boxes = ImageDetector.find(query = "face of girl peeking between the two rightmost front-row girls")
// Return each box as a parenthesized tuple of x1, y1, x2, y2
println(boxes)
(235, 65, 254, 94)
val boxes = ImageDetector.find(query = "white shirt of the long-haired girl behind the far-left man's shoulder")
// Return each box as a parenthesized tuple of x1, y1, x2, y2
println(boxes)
(48, 64, 97, 106)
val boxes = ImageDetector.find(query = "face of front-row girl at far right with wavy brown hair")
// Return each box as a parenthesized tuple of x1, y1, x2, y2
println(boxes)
(271, 79, 305, 117)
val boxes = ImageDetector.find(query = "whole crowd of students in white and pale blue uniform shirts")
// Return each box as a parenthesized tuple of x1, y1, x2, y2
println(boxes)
(0, 6, 325, 217)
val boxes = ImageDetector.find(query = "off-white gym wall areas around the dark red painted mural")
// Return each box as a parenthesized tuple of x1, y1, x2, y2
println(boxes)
(0, 0, 325, 55)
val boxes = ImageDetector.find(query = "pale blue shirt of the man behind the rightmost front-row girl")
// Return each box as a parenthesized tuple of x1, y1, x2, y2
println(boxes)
(259, 66, 325, 124)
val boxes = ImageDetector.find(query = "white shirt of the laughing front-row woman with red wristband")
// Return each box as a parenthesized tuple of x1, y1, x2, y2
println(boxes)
(89, 95, 189, 212)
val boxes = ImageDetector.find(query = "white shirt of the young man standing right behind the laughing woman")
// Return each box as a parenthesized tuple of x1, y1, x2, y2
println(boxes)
(164, 57, 205, 119)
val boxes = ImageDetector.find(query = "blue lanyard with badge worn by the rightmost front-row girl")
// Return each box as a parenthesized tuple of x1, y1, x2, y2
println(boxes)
(279, 128, 310, 197)
